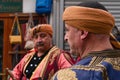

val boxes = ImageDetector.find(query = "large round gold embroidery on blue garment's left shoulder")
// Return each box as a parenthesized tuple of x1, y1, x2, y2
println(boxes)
(57, 69, 78, 80)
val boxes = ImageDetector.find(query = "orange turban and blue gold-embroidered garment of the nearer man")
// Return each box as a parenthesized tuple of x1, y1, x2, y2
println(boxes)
(51, 4, 120, 80)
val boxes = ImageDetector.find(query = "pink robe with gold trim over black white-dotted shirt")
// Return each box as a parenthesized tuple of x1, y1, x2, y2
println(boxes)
(12, 46, 74, 80)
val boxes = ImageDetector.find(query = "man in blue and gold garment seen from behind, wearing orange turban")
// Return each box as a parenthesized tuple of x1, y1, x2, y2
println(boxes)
(51, 1, 120, 80)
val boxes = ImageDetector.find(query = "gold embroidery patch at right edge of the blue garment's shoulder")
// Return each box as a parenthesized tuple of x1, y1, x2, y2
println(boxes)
(105, 57, 120, 70)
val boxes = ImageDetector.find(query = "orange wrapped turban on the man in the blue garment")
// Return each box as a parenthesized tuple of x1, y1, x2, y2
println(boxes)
(63, 6, 115, 34)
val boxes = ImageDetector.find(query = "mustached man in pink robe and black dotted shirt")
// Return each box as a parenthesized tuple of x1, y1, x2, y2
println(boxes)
(9, 24, 74, 80)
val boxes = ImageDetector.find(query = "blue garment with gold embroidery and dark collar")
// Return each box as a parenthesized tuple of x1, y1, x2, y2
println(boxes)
(51, 50, 120, 80)
